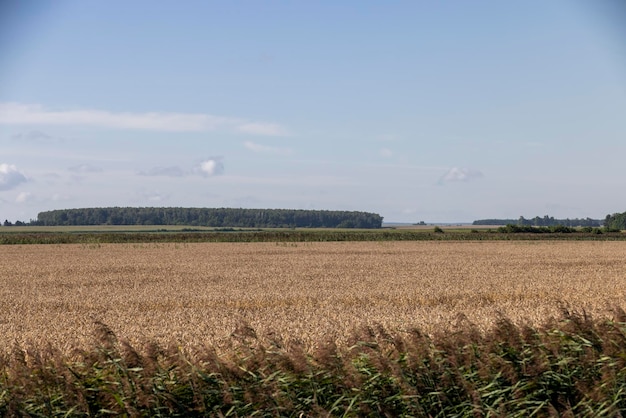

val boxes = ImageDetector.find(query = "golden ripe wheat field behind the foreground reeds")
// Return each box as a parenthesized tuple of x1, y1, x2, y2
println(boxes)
(0, 241, 626, 351)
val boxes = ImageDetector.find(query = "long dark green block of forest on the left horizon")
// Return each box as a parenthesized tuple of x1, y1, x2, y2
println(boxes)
(30, 207, 383, 228)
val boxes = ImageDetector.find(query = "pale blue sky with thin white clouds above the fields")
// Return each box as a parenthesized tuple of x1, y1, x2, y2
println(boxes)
(0, 0, 626, 223)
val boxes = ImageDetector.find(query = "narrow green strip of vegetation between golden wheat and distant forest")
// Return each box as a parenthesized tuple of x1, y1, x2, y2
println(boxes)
(0, 225, 626, 245)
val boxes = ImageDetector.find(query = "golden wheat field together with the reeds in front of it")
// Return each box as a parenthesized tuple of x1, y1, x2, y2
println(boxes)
(0, 238, 626, 417)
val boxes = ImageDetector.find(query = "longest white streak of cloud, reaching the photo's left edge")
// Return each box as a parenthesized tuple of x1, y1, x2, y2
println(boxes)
(0, 102, 287, 136)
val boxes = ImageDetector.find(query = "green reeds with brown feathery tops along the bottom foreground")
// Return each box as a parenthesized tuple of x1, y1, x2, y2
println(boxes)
(0, 311, 626, 417)
